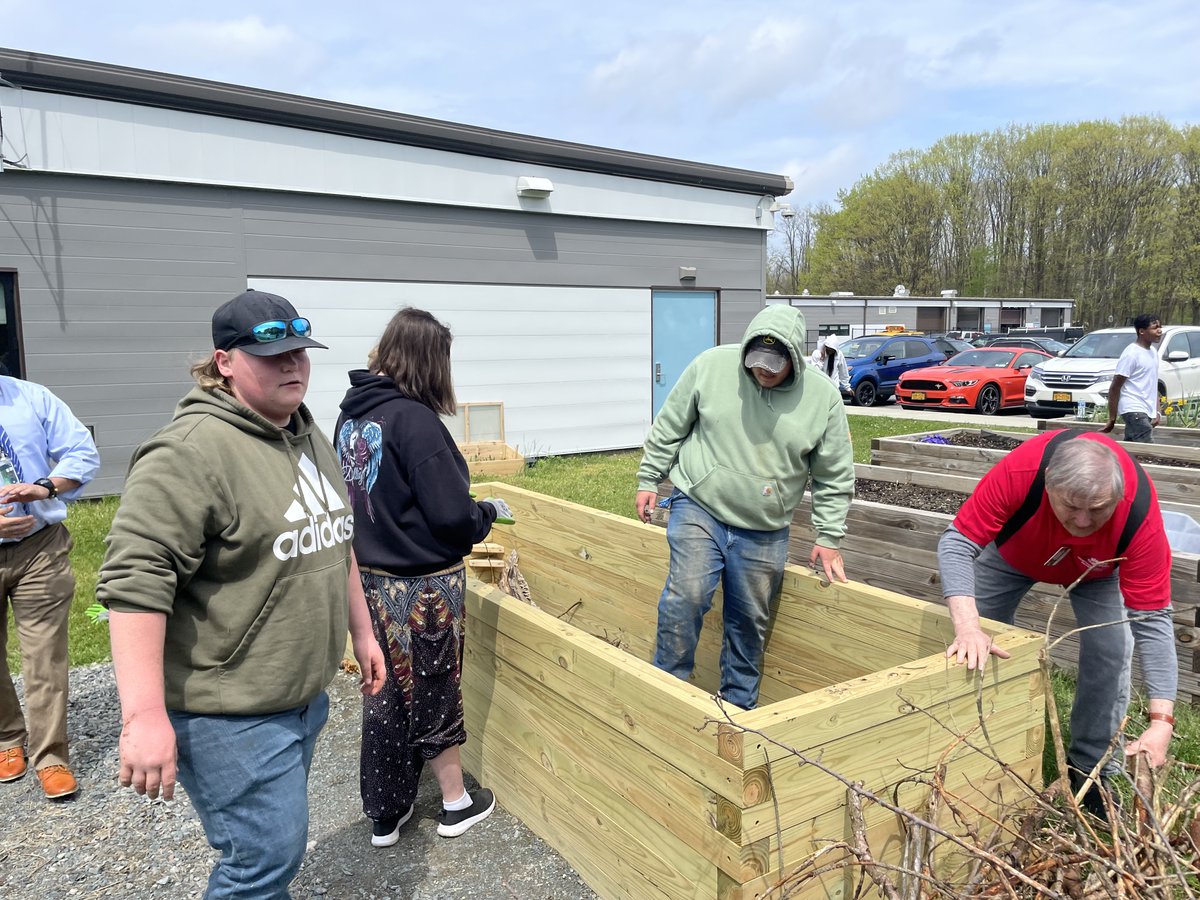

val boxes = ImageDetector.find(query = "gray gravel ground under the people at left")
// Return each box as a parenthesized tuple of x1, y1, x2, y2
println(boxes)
(0, 665, 595, 900)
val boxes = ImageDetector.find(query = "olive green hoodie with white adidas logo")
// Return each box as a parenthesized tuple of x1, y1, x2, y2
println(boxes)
(96, 388, 354, 715)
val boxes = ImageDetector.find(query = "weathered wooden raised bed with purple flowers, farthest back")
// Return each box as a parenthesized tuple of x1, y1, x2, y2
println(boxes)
(871, 428, 1200, 515)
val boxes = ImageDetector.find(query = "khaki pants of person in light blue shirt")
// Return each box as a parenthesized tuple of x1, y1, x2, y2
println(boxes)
(0, 524, 74, 769)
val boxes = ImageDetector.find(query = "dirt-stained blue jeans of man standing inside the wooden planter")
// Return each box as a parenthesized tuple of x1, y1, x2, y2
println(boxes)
(654, 491, 787, 709)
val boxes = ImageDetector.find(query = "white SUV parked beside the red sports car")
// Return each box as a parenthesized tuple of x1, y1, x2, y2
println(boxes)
(1025, 325, 1200, 419)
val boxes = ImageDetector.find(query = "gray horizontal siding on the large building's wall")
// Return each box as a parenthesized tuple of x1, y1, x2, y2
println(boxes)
(0, 170, 766, 494)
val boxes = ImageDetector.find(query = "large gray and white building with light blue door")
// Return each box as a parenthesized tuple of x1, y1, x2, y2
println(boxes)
(0, 49, 792, 494)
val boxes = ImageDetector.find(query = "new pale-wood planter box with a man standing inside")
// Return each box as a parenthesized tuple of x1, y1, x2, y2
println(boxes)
(463, 485, 1044, 900)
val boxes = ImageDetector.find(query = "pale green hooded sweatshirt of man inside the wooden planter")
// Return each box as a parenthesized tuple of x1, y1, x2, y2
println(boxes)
(637, 306, 854, 548)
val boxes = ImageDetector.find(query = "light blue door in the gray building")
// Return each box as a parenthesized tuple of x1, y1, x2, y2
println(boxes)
(650, 290, 716, 415)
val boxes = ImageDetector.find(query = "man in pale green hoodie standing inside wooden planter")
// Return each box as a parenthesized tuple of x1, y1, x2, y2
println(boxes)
(636, 306, 854, 709)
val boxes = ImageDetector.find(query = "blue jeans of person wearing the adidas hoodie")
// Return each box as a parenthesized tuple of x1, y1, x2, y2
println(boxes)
(169, 691, 329, 900)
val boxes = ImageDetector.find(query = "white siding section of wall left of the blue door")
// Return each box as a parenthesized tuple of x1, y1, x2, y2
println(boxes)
(250, 278, 650, 456)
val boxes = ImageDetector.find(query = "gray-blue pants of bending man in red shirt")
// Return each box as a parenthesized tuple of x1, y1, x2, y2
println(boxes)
(976, 544, 1133, 775)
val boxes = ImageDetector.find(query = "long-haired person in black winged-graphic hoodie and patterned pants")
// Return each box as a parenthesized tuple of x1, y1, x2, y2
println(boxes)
(336, 308, 509, 847)
